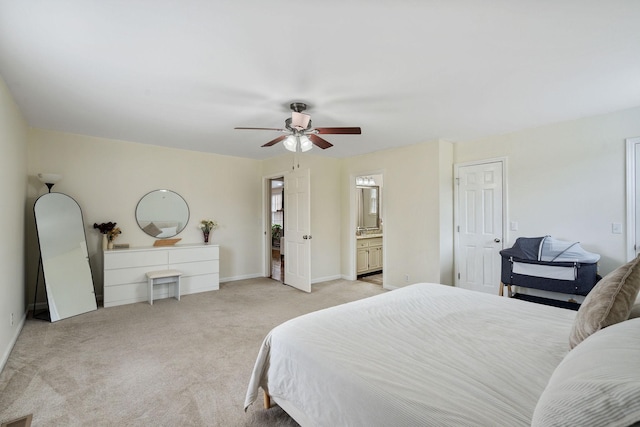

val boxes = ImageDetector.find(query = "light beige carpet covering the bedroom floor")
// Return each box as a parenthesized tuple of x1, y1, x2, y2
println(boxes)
(0, 279, 385, 426)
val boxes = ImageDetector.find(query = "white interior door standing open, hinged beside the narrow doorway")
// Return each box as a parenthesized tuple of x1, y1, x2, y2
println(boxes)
(284, 169, 311, 292)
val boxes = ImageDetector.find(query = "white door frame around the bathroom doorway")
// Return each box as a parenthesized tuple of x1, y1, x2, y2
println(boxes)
(345, 169, 387, 289)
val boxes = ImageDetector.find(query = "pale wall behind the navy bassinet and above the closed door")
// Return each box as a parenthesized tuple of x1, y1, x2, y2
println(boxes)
(454, 108, 640, 274)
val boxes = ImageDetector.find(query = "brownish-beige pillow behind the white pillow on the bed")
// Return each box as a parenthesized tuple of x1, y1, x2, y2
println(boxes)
(569, 257, 640, 348)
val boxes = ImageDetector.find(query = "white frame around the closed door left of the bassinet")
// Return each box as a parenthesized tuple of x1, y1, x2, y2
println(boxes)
(453, 157, 509, 287)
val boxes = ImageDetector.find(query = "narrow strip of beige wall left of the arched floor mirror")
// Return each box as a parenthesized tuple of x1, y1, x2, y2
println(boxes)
(0, 77, 28, 370)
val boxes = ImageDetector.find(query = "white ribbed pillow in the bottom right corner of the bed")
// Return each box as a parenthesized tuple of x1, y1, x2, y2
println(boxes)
(531, 319, 640, 427)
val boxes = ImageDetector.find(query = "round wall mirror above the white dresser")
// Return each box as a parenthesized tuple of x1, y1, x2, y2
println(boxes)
(136, 190, 189, 239)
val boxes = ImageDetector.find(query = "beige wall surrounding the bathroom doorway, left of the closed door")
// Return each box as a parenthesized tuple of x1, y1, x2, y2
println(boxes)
(342, 141, 452, 288)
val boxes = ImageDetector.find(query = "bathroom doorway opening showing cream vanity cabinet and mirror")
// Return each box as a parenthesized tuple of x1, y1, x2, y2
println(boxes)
(354, 173, 384, 286)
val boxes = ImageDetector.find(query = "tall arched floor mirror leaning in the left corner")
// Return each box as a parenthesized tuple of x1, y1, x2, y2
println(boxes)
(33, 193, 98, 322)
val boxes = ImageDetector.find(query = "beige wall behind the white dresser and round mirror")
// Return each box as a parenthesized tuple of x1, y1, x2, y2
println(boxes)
(27, 129, 262, 295)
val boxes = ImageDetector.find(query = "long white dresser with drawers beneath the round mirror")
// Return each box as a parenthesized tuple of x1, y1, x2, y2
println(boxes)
(103, 244, 220, 307)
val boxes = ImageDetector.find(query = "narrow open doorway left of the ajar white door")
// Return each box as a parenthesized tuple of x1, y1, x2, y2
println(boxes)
(269, 177, 284, 283)
